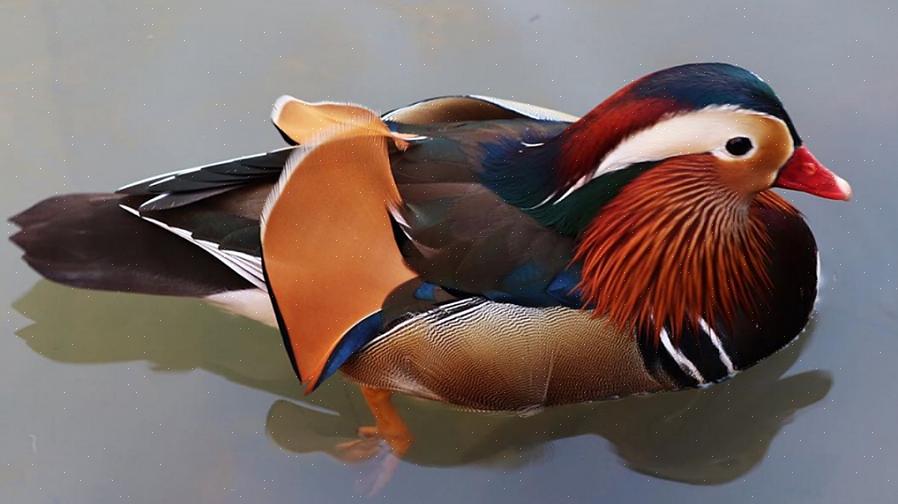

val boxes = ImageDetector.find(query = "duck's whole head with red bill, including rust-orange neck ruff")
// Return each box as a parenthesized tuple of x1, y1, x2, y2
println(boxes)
(534, 63, 851, 336)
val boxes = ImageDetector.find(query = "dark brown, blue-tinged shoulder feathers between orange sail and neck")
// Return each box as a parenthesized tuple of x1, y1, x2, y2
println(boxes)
(392, 119, 574, 306)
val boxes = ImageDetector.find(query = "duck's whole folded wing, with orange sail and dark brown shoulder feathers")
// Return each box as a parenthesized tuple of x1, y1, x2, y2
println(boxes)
(110, 96, 576, 390)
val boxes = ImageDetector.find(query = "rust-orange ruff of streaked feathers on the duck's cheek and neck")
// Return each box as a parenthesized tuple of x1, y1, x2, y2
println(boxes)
(575, 155, 797, 337)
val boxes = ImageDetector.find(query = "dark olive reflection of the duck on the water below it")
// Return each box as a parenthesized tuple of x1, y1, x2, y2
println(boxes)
(15, 281, 832, 494)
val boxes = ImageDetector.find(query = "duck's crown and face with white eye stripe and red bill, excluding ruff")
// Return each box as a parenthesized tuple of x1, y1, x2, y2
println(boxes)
(556, 63, 851, 202)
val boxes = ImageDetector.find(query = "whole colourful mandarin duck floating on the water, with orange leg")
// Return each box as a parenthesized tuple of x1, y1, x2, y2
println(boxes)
(12, 63, 851, 454)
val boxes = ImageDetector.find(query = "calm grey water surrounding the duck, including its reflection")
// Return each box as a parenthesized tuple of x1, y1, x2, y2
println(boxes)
(0, 0, 898, 503)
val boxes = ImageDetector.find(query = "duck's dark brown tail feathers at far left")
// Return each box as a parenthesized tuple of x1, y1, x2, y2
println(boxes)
(10, 194, 252, 297)
